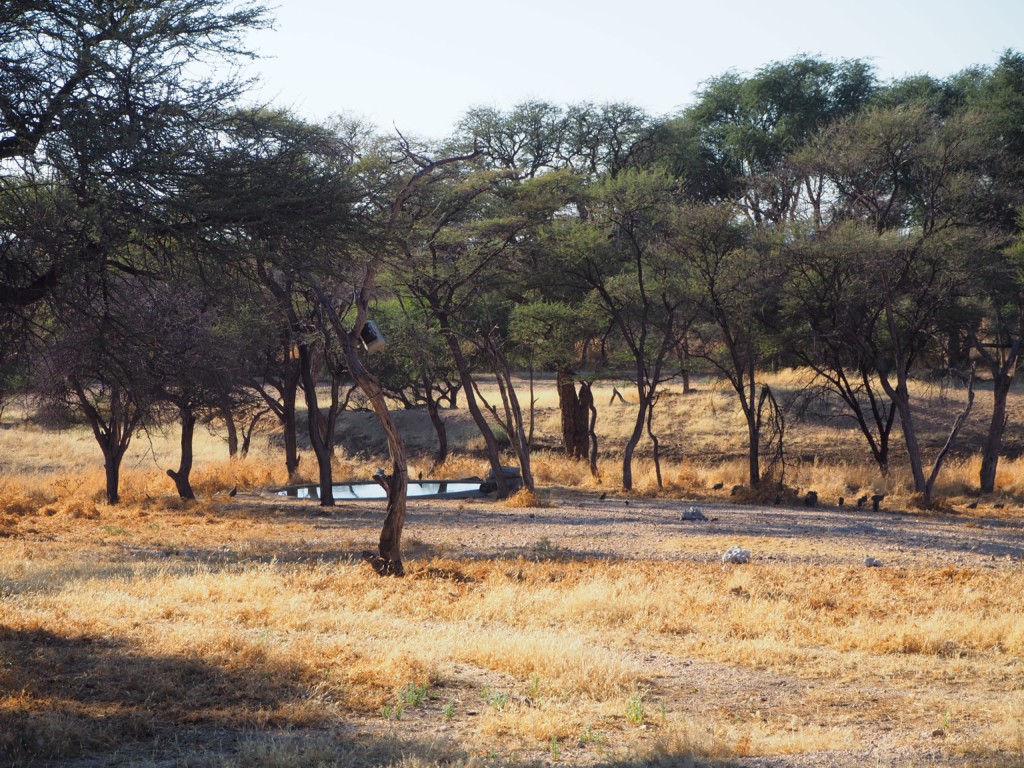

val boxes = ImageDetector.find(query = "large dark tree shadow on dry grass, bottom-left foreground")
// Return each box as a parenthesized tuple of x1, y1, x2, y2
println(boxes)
(0, 626, 323, 766)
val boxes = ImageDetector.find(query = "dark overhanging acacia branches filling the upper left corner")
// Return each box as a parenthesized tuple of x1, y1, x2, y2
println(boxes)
(0, 0, 267, 319)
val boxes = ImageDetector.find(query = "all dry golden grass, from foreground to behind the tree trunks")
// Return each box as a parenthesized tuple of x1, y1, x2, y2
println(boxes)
(0, 372, 1024, 768)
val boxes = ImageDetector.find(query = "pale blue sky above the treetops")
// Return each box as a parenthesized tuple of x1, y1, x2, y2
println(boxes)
(241, 0, 1024, 137)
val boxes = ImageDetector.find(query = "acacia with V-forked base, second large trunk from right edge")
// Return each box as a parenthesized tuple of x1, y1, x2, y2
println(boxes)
(794, 105, 987, 503)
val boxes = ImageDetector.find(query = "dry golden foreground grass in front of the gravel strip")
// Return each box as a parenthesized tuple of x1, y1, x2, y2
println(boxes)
(6, 507, 1024, 765)
